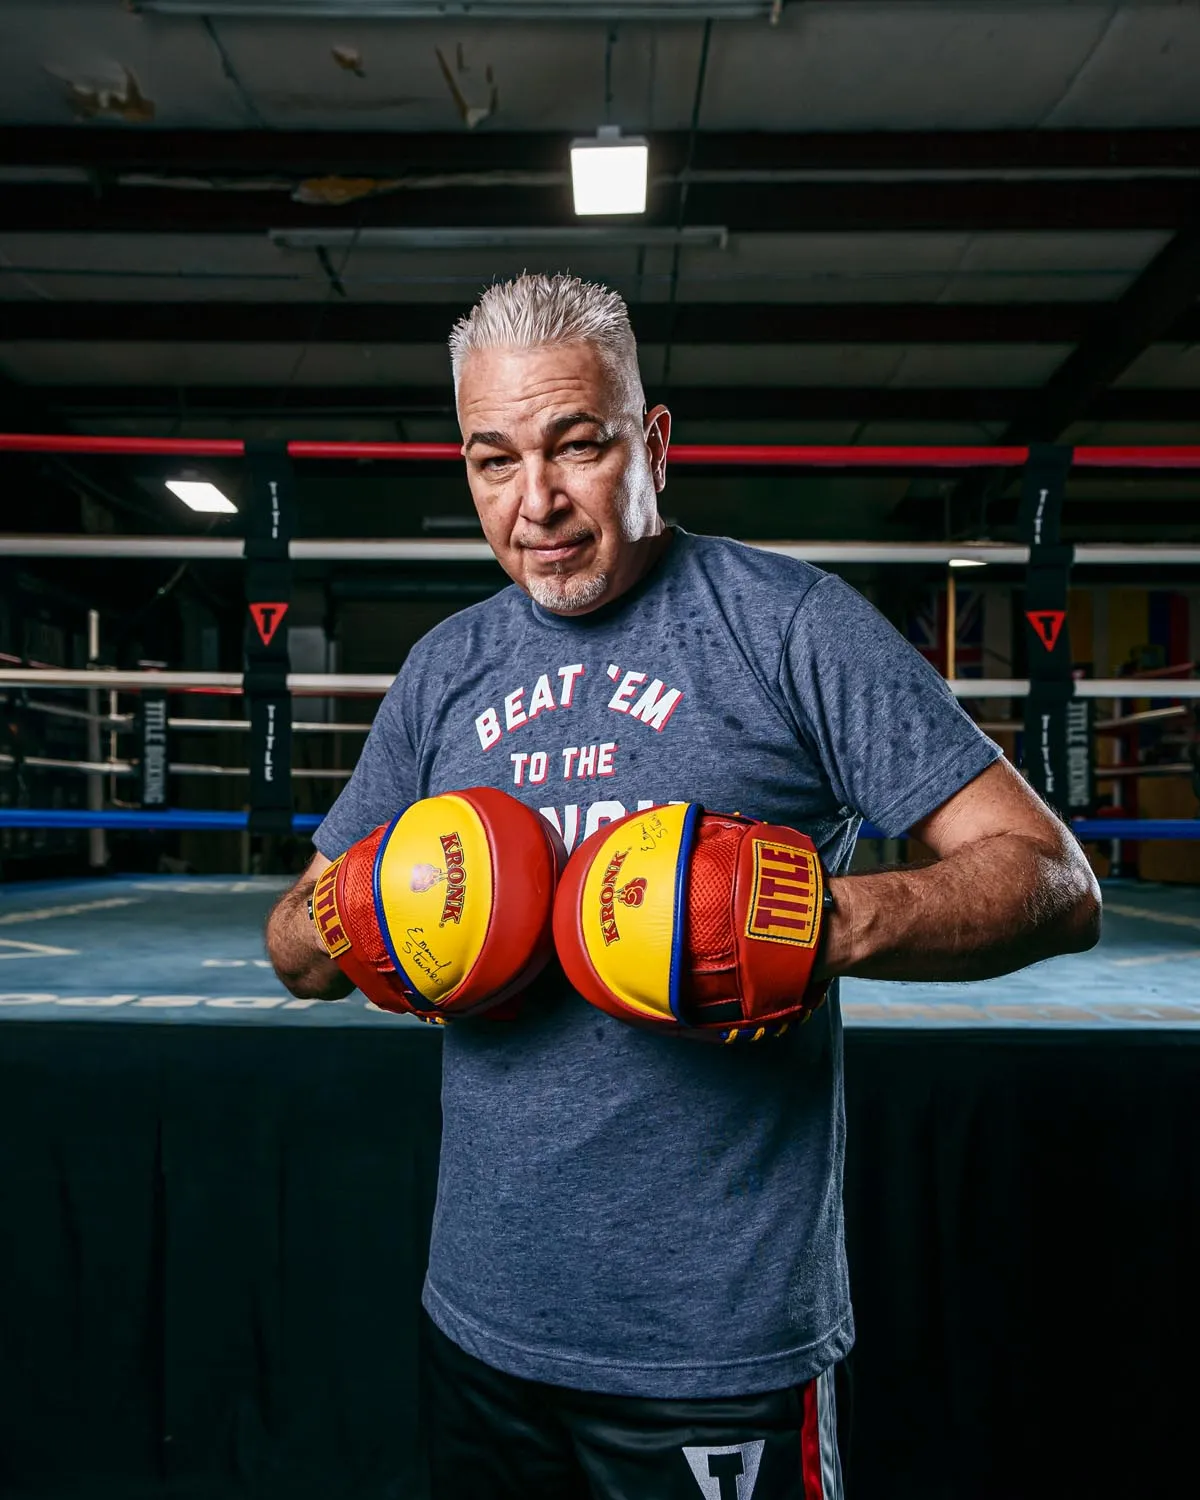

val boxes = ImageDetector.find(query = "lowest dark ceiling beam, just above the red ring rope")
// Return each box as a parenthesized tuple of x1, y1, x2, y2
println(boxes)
(30, 381, 1200, 426)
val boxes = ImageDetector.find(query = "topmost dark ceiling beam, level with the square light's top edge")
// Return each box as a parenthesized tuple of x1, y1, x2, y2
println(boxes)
(0, 125, 1200, 177)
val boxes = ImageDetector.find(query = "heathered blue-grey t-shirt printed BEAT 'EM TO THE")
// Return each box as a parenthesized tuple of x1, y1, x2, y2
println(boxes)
(314, 530, 1001, 1398)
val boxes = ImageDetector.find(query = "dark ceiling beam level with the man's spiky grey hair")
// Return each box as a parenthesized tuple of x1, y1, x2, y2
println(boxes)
(3, 300, 1200, 344)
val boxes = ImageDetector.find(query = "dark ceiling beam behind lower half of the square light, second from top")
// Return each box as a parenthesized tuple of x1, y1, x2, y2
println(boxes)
(5, 178, 1194, 236)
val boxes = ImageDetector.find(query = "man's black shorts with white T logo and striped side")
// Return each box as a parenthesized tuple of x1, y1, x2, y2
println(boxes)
(422, 1316, 849, 1500)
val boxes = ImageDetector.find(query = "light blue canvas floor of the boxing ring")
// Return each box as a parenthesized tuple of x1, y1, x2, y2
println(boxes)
(0, 876, 1200, 1029)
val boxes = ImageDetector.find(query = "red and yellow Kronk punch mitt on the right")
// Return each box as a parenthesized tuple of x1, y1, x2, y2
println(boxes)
(554, 803, 825, 1043)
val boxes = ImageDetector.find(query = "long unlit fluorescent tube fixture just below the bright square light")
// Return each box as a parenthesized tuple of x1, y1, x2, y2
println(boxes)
(267, 224, 729, 251)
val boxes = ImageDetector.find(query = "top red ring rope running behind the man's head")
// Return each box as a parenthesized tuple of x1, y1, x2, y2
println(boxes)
(0, 432, 1200, 470)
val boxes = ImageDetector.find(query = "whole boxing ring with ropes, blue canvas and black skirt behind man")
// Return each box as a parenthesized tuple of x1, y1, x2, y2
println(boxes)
(0, 435, 1200, 1500)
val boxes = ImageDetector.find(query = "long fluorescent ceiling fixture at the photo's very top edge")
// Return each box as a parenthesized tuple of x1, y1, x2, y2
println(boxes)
(132, 0, 777, 21)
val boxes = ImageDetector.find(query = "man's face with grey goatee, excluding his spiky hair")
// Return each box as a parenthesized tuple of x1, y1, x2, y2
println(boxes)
(458, 344, 671, 615)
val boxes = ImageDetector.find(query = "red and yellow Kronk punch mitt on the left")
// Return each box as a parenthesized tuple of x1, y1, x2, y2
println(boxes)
(312, 786, 566, 1025)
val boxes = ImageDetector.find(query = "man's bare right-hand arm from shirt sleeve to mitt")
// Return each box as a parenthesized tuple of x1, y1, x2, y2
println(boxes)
(818, 761, 1101, 981)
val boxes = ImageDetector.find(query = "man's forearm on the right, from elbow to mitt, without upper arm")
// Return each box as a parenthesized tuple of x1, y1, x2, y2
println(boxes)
(821, 834, 1100, 981)
